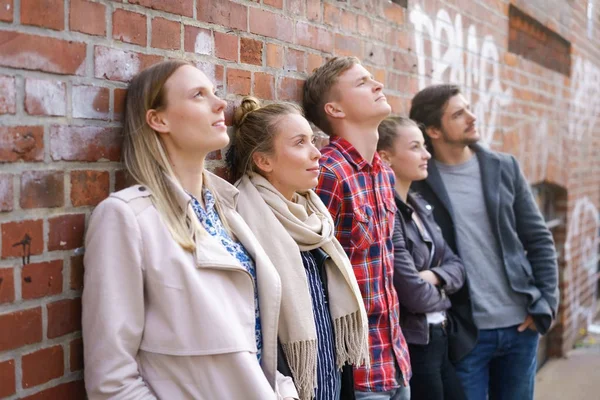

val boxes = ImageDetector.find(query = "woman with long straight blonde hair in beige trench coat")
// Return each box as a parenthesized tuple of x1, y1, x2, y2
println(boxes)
(83, 61, 298, 400)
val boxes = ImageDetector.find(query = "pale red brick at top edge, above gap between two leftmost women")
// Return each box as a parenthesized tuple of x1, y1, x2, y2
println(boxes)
(196, 0, 248, 31)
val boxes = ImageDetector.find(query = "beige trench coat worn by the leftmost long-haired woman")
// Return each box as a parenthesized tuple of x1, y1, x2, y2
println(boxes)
(82, 174, 298, 400)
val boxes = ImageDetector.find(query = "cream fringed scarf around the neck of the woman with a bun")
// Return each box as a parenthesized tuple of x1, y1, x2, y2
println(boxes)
(237, 173, 369, 400)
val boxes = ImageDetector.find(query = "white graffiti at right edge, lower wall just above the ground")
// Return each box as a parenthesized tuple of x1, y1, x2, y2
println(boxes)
(564, 197, 600, 332)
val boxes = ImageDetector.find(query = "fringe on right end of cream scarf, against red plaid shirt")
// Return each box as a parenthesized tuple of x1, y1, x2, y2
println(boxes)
(333, 311, 371, 369)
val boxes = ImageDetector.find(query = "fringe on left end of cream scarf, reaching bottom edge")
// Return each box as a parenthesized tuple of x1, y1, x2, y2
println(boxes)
(281, 340, 317, 400)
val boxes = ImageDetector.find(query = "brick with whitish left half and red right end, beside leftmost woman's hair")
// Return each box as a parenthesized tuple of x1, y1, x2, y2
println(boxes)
(50, 125, 122, 161)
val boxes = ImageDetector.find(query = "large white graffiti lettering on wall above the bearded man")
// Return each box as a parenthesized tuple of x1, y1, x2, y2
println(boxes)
(410, 5, 512, 144)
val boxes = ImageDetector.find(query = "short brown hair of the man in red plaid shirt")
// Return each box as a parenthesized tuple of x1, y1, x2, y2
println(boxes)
(302, 57, 360, 135)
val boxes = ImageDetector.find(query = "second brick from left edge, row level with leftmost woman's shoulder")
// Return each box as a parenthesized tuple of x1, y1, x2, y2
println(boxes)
(19, 171, 65, 208)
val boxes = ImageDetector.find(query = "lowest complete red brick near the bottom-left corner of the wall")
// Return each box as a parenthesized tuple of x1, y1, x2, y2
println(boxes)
(22, 345, 65, 389)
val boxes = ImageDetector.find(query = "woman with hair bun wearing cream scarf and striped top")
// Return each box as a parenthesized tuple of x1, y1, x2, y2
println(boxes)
(227, 97, 369, 400)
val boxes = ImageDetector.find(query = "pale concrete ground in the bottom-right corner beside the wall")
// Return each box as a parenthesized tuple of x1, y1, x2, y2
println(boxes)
(535, 321, 600, 400)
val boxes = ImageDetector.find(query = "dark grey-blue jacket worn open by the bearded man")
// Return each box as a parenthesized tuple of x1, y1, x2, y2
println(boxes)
(413, 145, 558, 361)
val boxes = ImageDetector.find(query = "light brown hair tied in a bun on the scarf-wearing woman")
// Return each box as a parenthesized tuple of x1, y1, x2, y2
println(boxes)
(225, 96, 302, 182)
